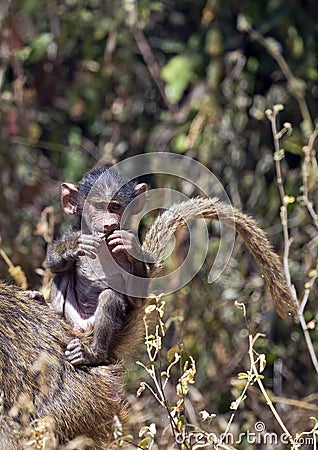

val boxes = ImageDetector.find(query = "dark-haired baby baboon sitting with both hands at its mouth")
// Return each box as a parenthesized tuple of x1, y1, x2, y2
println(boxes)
(47, 167, 147, 365)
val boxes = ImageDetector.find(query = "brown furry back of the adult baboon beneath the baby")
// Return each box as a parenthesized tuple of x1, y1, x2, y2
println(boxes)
(0, 283, 127, 450)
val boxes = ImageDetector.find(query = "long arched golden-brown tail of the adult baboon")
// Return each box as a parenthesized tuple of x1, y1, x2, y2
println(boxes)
(142, 198, 297, 319)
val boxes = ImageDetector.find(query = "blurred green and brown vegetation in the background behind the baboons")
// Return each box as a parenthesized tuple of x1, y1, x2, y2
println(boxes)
(0, 0, 318, 448)
